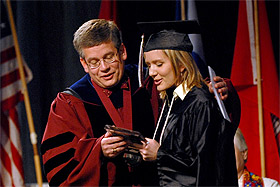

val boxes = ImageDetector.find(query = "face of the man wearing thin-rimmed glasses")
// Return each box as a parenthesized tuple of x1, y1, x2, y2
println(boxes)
(80, 42, 127, 88)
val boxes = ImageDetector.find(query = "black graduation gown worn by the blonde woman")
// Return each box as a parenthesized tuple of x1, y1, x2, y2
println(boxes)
(156, 85, 238, 186)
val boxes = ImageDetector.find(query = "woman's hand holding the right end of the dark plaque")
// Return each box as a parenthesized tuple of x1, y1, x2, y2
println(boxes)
(139, 138, 160, 161)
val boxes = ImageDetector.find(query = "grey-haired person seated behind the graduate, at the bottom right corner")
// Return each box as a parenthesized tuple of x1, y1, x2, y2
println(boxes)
(234, 128, 280, 187)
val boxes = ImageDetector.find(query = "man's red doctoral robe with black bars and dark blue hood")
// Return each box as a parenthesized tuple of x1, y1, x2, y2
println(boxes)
(41, 65, 158, 186)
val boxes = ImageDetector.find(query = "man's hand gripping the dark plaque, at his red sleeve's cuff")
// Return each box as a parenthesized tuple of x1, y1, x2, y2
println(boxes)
(101, 132, 127, 158)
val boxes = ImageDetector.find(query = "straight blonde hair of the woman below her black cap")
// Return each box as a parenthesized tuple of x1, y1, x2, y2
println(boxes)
(160, 49, 205, 98)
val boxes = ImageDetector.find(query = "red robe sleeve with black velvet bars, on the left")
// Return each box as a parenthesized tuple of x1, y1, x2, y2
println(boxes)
(41, 93, 104, 186)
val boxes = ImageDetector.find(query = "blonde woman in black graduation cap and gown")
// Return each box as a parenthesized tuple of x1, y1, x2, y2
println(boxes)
(140, 21, 237, 186)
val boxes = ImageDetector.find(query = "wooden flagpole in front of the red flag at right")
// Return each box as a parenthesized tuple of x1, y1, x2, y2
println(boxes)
(254, 0, 265, 177)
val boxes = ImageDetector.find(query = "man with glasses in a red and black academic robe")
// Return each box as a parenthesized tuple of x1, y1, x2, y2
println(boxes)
(41, 20, 161, 186)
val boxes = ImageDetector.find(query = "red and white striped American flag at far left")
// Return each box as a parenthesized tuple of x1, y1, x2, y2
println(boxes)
(0, 1, 32, 186)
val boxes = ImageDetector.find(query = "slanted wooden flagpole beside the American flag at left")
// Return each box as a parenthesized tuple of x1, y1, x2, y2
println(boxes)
(7, 0, 43, 187)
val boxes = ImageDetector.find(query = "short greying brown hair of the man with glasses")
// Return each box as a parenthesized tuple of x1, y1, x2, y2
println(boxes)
(73, 19, 122, 58)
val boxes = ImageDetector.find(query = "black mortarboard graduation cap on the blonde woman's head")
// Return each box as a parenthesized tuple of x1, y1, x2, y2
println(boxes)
(137, 20, 200, 52)
